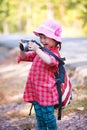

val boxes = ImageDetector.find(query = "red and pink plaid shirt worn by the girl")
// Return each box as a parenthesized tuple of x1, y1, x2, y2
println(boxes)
(19, 47, 60, 106)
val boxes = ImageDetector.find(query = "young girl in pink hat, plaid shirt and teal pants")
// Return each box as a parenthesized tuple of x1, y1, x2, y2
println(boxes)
(20, 20, 62, 130)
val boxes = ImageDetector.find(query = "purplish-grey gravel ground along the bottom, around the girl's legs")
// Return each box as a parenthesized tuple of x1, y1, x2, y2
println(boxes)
(0, 110, 87, 130)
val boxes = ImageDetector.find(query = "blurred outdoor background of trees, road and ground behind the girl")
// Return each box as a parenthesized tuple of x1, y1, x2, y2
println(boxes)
(0, 0, 87, 130)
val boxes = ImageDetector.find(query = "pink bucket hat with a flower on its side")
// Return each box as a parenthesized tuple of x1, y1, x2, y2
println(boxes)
(33, 20, 62, 43)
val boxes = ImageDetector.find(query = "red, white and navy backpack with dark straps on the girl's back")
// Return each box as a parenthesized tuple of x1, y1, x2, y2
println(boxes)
(20, 40, 72, 120)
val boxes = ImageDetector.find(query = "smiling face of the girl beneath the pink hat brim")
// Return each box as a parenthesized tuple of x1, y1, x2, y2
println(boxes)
(39, 34, 56, 48)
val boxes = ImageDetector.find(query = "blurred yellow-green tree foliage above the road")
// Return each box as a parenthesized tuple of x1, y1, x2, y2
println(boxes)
(0, 0, 87, 33)
